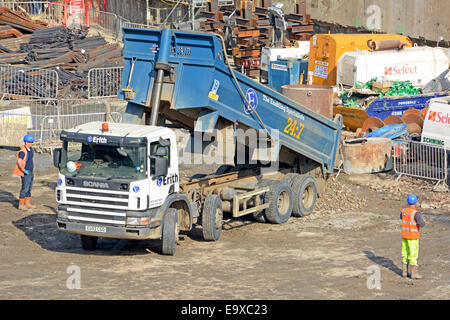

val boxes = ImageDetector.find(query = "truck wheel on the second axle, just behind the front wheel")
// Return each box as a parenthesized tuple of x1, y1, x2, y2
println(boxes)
(202, 194, 223, 241)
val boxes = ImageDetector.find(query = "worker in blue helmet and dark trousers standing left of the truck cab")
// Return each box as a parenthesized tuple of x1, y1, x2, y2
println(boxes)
(13, 134, 36, 210)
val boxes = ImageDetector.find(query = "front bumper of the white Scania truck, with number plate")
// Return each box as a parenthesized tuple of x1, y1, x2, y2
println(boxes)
(56, 219, 161, 240)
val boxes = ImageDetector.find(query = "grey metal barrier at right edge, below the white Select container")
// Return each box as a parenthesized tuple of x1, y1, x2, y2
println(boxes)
(392, 140, 449, 190)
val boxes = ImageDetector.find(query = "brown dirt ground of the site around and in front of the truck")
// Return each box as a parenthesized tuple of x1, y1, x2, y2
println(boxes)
(0, 149, 450, 300)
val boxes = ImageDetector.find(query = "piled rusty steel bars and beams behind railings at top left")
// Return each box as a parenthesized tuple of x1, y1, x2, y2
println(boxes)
(0, 8, 123, 99)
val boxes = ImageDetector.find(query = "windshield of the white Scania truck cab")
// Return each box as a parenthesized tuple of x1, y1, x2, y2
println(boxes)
(60, 141, 147, 180)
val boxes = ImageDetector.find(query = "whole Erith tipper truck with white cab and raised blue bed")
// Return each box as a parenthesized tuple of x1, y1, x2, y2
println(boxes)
(54, 28, 342, 255)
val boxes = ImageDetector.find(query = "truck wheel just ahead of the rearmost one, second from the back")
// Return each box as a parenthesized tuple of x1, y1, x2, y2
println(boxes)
(264, 181, 292, 224)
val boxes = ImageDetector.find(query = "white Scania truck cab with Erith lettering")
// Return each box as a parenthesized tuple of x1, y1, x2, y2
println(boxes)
(54, 122, 195, 254)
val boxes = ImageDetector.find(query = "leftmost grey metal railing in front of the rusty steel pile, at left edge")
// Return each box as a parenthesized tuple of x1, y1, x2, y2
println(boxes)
(0, 65, 59, 99)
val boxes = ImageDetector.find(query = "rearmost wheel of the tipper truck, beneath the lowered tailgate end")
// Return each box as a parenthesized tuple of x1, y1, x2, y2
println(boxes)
(292, 176, 317, 217)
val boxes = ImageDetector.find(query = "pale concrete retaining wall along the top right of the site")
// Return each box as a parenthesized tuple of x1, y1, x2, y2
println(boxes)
(286, 0, 450, 42)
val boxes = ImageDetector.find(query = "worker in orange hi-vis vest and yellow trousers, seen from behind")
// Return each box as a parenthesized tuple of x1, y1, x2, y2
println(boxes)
(400, 194, 425, 279)
